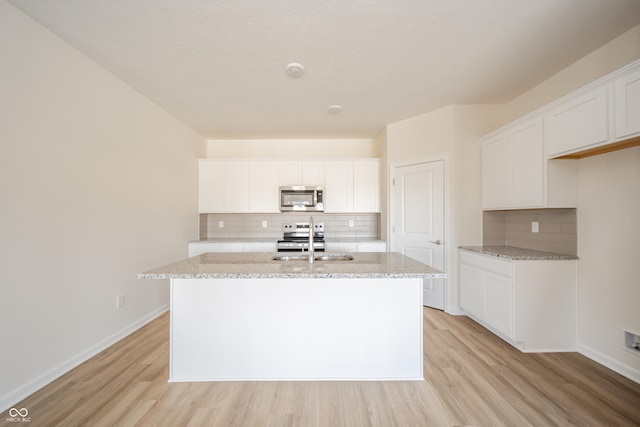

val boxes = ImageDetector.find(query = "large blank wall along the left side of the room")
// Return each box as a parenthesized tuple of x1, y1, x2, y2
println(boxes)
(0, 1, 205, 412)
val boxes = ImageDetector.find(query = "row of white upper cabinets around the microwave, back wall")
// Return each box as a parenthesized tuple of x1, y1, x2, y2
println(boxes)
(198, 159, 380, 213)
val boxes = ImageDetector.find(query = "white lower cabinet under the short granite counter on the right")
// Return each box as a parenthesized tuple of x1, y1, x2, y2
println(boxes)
(459, 250, 576, 352)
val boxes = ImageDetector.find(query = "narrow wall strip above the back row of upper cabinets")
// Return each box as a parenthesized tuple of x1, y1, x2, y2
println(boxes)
(207, 138, 382, 158)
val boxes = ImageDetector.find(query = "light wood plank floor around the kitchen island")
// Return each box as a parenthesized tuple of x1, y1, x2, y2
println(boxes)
(6, 309, 640, 427)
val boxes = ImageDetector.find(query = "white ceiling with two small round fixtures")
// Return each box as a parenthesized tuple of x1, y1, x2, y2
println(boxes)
(10, 0, 640, 138)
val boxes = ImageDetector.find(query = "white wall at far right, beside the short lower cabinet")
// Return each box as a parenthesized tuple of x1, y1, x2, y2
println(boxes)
(578, 147, 640, 381)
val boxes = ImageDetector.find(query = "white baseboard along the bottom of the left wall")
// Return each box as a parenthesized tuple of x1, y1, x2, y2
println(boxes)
(0, 304, 169, 413)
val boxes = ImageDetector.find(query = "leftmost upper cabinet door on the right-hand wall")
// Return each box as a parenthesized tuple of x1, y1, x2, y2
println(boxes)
(482, 132, 513, 209)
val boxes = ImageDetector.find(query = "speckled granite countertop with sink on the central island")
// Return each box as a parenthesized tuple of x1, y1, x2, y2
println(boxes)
(138, 252, 447, 279)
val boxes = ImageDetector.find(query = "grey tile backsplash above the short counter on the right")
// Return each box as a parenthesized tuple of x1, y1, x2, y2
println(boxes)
(482, 209, 578, 255)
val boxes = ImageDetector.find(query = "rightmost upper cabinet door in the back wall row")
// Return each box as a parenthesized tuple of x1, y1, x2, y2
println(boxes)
(353, 160, 380, 212)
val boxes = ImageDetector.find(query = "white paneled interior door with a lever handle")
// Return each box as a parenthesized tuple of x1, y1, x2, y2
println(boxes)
(392, 160, 444, 310)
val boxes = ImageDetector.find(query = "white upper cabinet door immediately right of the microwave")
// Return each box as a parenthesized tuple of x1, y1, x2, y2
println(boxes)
(324, 160, 353, 213)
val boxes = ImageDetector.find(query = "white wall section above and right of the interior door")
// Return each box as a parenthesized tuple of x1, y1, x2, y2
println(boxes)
(386, 105, 503, 313)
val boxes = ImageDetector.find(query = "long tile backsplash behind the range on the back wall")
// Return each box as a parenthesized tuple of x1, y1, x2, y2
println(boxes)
(199, 212, 380, 239)
